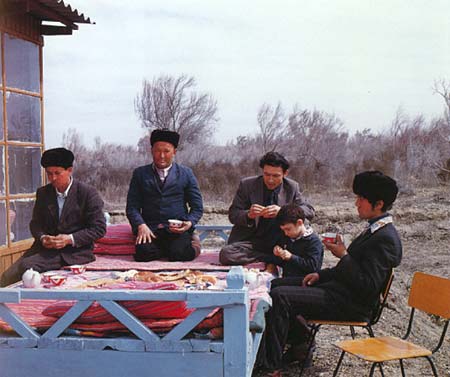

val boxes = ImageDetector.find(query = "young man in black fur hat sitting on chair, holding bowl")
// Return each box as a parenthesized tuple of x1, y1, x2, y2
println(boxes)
(258, 171, 402, 375)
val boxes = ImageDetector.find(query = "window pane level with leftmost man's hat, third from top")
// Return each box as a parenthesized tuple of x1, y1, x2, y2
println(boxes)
(8, 146, 41, 194)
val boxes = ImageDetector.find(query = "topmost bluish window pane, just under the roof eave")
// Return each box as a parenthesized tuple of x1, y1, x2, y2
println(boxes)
(5, 34, 40, 93)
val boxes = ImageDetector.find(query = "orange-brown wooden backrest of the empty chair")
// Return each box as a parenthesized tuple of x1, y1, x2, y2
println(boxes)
(408, 272, 450, 319)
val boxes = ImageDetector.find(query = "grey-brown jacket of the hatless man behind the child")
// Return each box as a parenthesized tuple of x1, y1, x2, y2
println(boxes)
(228, 176, 314, 244)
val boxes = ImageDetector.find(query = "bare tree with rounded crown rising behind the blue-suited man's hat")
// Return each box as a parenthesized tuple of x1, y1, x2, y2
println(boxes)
(135, 75, 218, 149)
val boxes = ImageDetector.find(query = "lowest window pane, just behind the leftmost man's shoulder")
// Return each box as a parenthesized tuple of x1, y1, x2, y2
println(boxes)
(9, 199, 34, 241)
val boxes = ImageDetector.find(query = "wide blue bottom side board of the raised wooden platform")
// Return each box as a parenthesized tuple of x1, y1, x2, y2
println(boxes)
(0, 349, 224, 377)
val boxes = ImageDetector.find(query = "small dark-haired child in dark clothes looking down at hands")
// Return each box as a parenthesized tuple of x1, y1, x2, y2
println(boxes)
(271, 203, 323, 289)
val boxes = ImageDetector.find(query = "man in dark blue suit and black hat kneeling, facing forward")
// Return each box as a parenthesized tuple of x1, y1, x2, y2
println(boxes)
(126, 130, 203, 262)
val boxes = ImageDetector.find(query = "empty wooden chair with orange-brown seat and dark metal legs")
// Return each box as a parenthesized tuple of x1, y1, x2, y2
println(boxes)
(333, 272, 450, 377)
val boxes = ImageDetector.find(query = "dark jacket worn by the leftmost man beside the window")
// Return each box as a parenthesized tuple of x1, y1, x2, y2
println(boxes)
(30, 179, 106, 265)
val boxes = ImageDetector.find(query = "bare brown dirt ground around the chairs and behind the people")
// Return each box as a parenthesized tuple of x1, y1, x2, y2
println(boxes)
(202, 187, 450, 377)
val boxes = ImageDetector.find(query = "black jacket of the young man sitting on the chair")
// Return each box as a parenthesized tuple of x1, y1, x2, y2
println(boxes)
(318, 217, 402, 320)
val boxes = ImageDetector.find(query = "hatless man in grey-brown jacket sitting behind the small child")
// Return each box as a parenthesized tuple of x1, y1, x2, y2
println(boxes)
(220, 152, 314, 265)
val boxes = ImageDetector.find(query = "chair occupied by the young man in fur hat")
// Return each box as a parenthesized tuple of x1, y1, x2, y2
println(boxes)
(298, 269, 394, 377)
